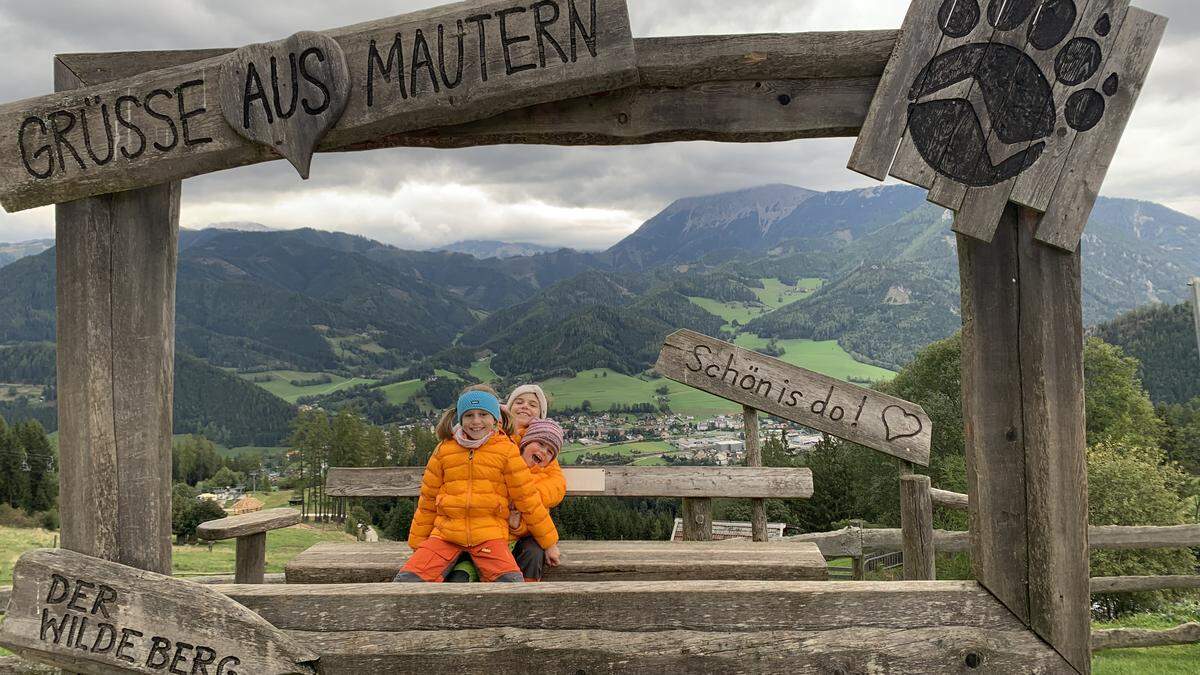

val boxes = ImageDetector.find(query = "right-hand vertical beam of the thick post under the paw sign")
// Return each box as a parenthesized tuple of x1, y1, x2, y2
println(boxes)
(1017, 207, 1091, 671)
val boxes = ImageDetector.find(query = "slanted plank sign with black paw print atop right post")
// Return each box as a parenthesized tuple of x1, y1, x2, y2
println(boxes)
(850, 0, 1166, 251)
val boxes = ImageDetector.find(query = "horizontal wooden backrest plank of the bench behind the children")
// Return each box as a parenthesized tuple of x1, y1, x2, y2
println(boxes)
(325, 466, 812, 498)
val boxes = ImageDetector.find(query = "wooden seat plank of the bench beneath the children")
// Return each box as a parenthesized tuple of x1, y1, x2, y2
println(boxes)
(284, 540, 829, 584)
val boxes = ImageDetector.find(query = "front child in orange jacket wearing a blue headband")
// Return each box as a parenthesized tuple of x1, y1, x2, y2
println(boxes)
(395, 387, 558, 581)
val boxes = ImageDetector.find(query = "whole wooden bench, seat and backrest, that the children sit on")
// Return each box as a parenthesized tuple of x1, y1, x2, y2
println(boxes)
(309, 466, 828, 584)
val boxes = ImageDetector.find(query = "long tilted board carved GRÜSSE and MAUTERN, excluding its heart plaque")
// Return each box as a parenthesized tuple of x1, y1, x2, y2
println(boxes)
(0, 0, 637, 209)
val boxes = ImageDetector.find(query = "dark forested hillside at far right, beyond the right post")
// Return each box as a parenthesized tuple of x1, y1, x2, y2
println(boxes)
(1096, 303, 1200, 404)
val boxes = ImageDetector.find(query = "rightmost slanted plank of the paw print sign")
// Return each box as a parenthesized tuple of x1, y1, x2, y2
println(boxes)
(1037, 7, 1166, 251)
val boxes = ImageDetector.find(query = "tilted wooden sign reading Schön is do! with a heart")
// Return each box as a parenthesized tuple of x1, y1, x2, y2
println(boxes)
(654, 330, 932, 466)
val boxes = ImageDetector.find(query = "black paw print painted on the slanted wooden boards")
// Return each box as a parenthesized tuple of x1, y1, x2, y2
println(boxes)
(908, 0, 1118, 187)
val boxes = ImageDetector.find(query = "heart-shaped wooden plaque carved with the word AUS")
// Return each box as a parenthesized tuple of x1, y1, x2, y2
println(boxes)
(218, 31, 350, 179)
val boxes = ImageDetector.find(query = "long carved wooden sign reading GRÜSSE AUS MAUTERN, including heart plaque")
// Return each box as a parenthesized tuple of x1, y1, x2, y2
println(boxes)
(0, 0, 638, 211)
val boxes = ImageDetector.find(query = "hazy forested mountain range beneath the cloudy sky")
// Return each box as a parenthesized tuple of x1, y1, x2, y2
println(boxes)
(0, 185, 1200, 422)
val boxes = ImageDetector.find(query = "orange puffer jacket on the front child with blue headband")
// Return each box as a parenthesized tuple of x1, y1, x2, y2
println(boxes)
(408, 434, 558, 549)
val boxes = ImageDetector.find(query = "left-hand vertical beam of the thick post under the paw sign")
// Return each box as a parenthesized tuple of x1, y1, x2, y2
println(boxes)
(958, 207, 1030, 621)
